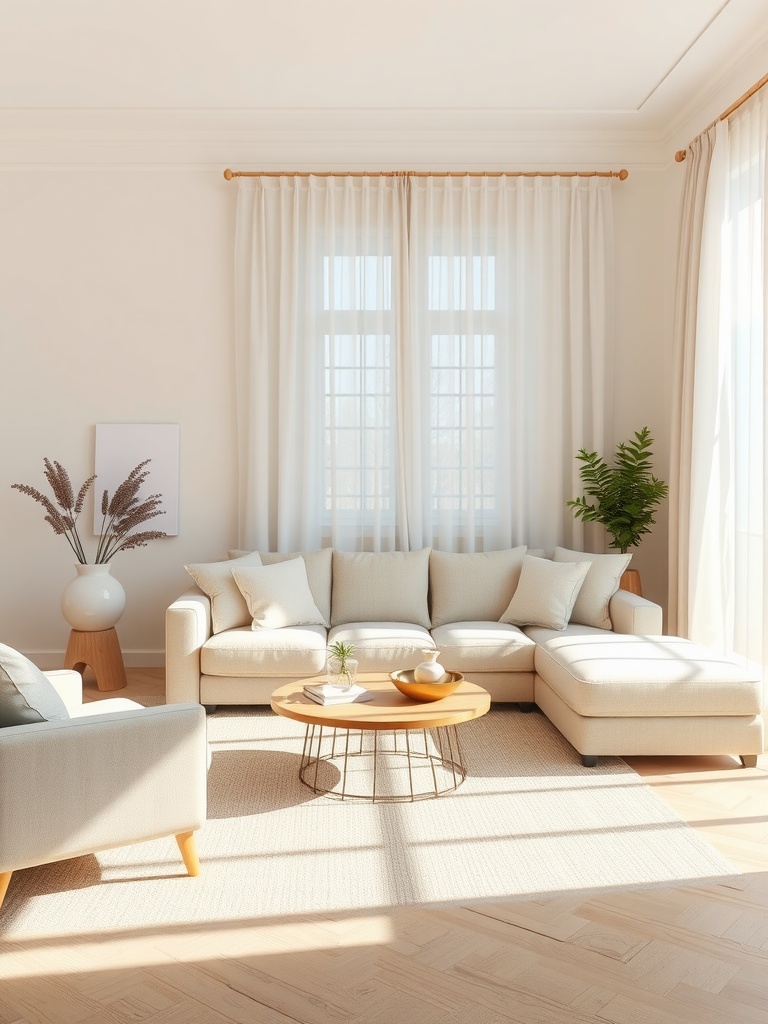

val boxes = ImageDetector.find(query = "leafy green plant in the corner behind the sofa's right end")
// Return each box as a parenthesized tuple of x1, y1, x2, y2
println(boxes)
(566, 427, 669, 592)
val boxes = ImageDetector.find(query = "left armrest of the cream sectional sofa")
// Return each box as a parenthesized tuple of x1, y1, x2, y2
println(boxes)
(165, 587, 211, 703)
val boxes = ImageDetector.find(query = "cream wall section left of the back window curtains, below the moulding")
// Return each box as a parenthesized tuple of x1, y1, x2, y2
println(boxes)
(0, 165, 236, 667)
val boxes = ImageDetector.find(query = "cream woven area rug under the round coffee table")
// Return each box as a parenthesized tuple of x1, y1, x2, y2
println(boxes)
(0, 701, 738, 939)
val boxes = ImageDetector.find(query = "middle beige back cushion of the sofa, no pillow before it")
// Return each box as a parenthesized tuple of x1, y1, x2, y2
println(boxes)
(331, 548, 431, 626)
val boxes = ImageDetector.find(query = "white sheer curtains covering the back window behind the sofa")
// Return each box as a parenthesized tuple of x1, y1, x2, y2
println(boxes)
(236, 175, 612, 551)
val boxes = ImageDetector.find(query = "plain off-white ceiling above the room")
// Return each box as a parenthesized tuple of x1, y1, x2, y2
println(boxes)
(0, 0, 768, 140)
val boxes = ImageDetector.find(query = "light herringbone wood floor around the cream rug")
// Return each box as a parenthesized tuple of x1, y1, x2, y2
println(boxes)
(0, 670, 768, 1024)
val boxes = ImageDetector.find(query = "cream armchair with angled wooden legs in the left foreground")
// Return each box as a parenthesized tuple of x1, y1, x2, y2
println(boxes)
(0, 671, 208, 905)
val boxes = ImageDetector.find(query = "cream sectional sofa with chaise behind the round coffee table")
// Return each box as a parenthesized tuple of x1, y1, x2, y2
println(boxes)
(166, 547, 763, 765)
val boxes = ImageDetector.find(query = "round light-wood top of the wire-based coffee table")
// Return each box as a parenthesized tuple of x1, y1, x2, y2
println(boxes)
(271, 672, 490, 729)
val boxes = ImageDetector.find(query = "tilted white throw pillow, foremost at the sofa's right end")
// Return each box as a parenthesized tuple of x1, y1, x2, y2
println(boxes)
(499, 555, 590, 630)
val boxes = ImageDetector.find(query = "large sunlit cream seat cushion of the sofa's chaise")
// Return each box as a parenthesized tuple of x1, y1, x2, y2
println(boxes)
(535, 632, 763, 718)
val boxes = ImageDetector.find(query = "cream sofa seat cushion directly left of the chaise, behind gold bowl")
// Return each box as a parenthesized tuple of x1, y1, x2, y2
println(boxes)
(432, 622, 536, 681)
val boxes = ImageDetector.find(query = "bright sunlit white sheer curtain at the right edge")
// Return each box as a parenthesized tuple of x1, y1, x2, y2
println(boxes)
(687, 90, 768, 666)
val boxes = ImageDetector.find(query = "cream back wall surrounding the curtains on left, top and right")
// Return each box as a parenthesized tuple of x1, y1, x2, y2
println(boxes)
(12, 25, 768, 668)
